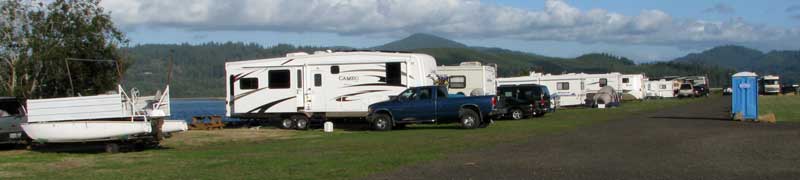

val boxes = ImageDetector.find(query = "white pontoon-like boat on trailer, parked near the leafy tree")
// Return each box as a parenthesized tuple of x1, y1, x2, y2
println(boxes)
(21, 85, 188, 151)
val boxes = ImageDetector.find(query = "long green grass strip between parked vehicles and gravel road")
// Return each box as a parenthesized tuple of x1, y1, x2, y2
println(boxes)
(0, 99, 702, 179)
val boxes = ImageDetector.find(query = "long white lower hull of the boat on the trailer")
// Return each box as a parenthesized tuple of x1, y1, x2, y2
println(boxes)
(22, 121, 158, 143)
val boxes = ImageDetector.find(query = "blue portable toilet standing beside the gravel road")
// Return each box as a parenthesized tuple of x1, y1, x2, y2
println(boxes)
(731, 72, 758, 120)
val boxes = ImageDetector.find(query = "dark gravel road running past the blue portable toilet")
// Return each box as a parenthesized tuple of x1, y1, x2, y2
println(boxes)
(367, 97, 800, 179)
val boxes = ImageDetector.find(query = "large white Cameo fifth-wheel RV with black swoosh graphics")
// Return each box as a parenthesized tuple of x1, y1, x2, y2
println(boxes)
(225, 51, 437, 129)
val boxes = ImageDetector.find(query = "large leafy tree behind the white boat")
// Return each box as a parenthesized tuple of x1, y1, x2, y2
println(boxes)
(0, 0, 128, 98)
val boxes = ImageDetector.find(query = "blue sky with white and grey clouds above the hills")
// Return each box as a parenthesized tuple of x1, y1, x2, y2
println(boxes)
(101, 0, 800, 62)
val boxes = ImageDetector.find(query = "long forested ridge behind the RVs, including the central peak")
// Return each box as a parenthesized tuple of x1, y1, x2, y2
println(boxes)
(122, 35, 732, 97)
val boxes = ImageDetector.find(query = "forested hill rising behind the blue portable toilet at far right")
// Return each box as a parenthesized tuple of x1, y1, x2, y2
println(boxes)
(674, 45, 800, 83)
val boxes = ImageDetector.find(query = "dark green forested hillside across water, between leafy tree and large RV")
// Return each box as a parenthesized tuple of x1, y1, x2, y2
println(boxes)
(122, 42, 350, 97)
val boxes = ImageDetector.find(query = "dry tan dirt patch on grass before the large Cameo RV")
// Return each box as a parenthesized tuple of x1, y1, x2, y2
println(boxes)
(162, 128, 298, 148)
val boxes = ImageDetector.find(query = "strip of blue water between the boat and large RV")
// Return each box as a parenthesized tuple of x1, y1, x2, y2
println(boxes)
(170, 99, 239, 122)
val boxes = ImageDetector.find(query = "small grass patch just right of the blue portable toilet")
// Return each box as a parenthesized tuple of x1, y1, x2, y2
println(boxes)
(758, 96, 800, 123)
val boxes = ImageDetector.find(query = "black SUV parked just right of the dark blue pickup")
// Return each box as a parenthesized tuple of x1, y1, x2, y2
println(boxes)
(496, 84, 551, 120)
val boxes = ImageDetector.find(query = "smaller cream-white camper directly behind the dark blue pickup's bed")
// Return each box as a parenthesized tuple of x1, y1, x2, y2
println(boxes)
(436, 61, 497, 96)
